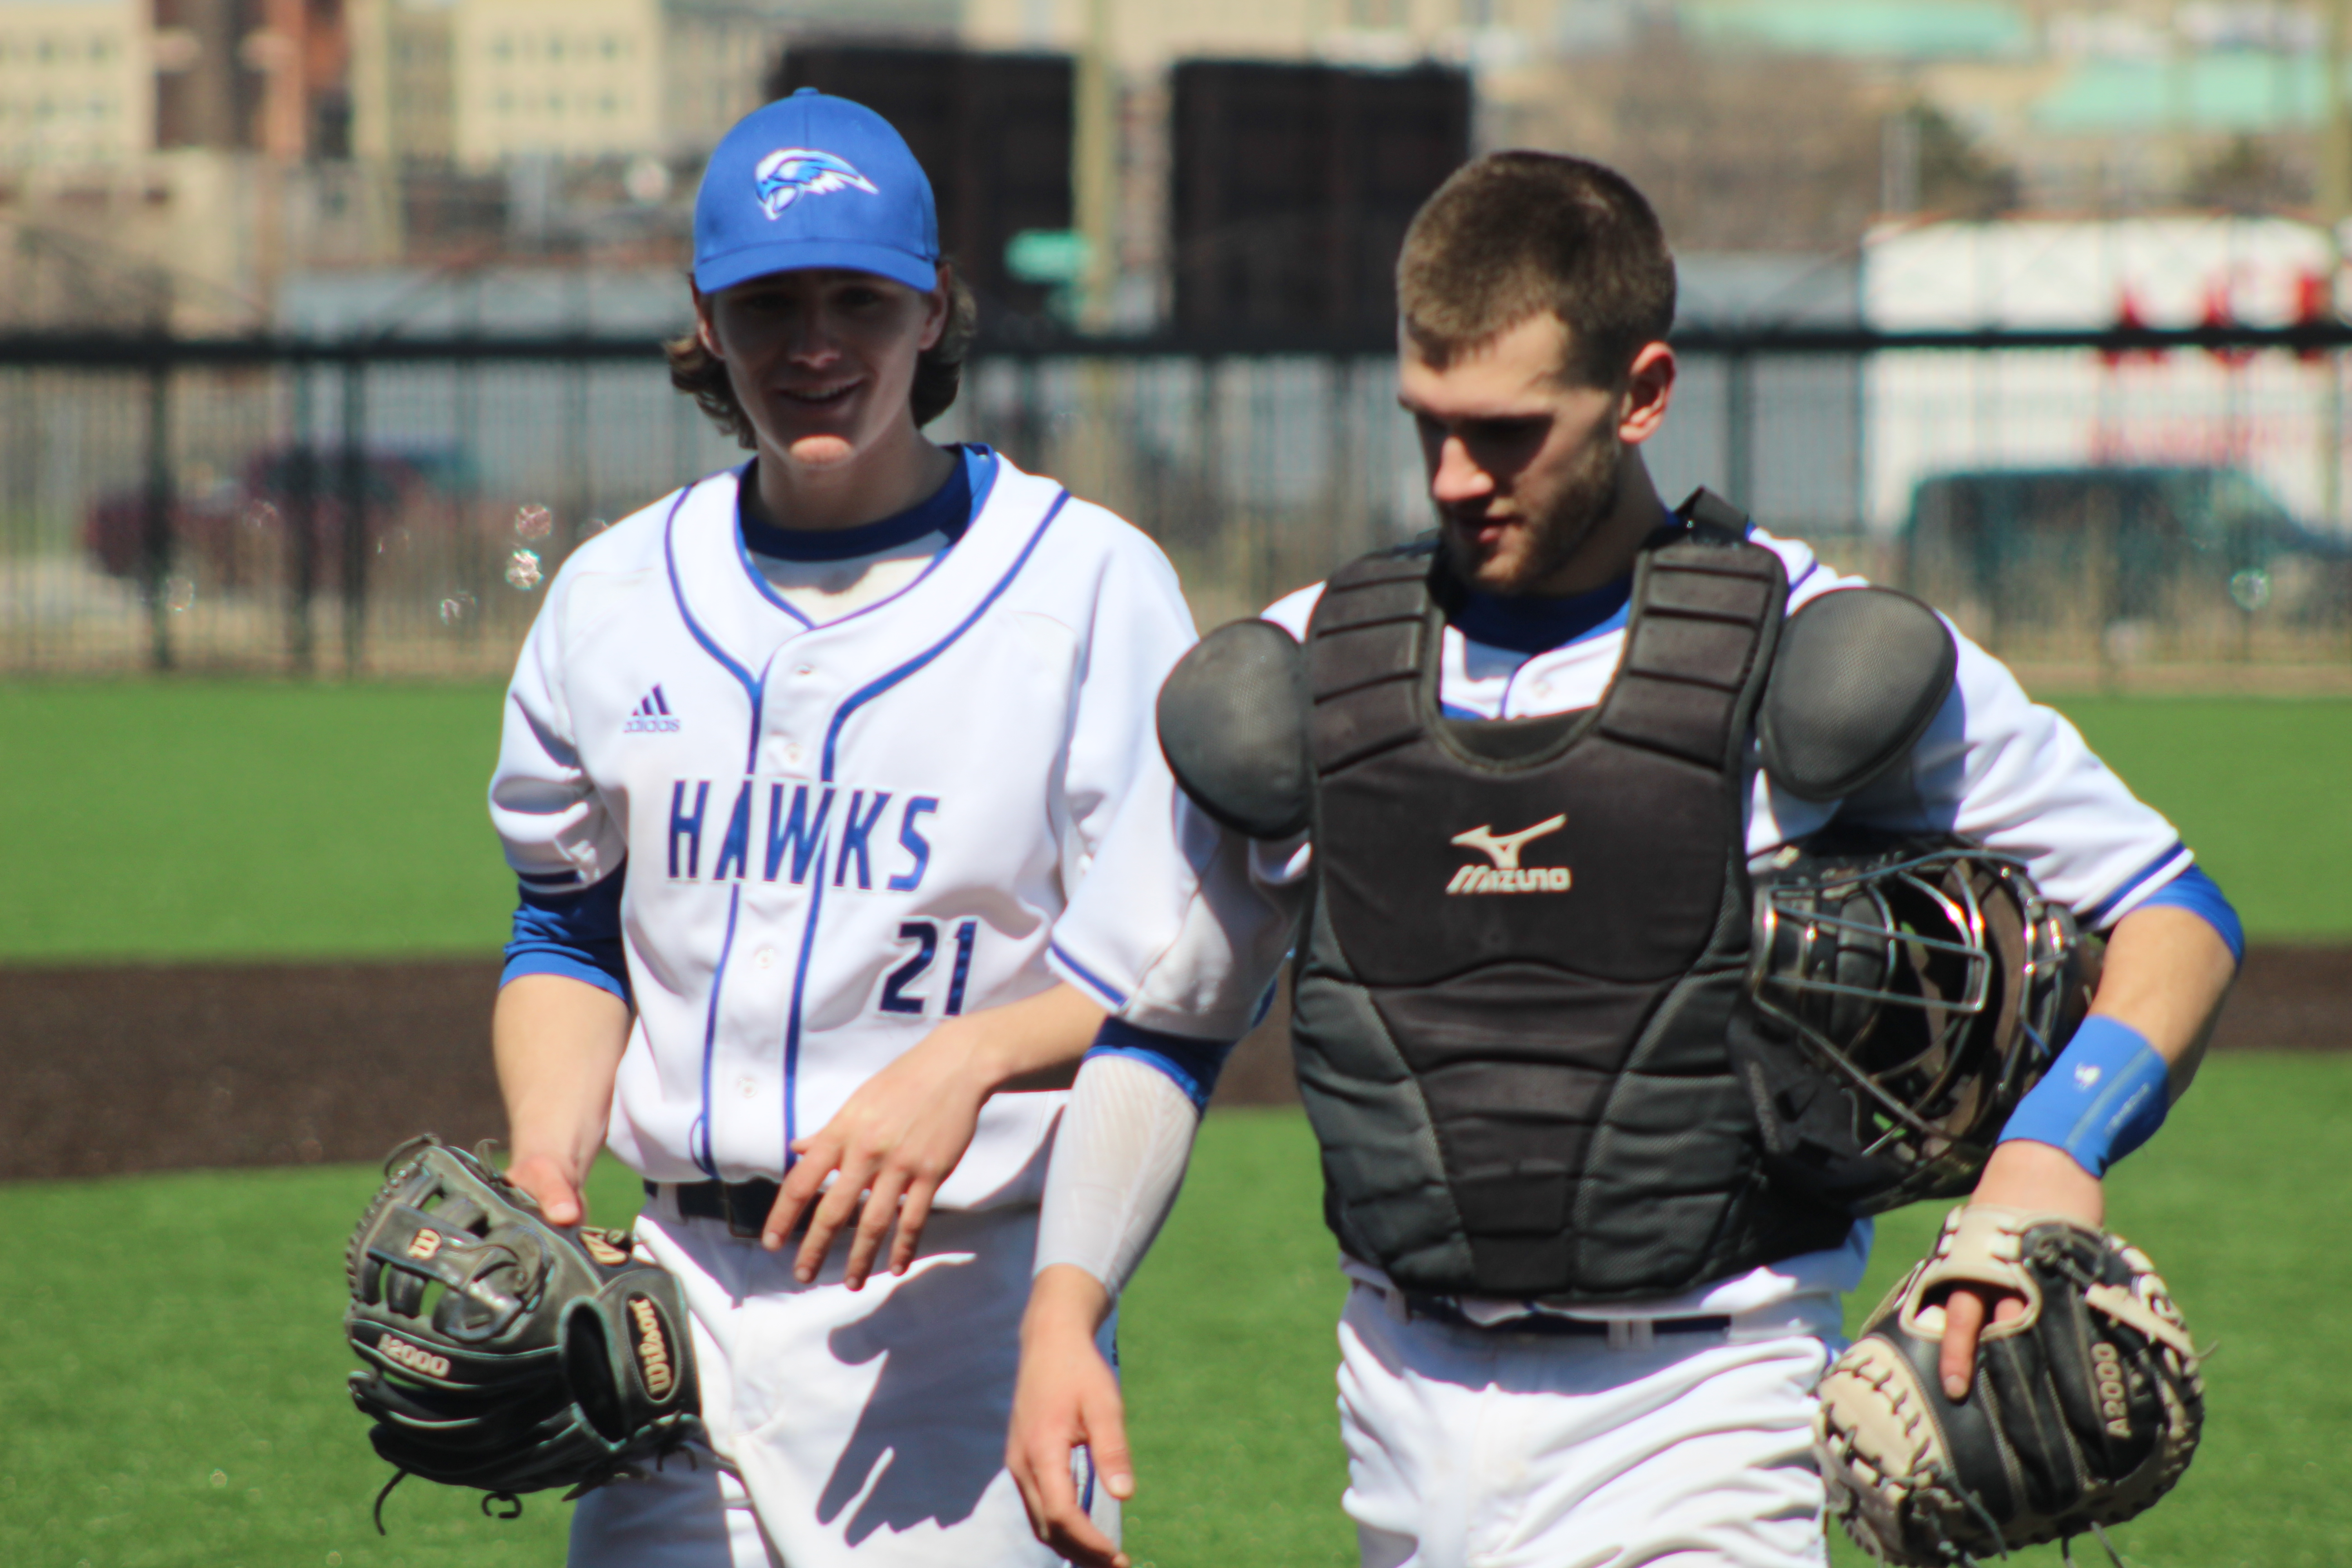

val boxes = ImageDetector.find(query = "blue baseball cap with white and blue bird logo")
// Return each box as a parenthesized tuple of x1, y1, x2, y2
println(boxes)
(694, 87, 938, 294)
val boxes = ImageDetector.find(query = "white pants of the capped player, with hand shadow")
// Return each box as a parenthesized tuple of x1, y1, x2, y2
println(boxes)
(569, 1196, 1117, 1568)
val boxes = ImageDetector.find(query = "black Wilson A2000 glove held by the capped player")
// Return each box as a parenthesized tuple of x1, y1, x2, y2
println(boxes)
(343, 1136, 701, 1530)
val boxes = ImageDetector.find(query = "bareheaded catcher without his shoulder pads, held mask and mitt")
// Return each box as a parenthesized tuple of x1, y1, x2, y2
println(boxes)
(1009, 153, 2241, 1568)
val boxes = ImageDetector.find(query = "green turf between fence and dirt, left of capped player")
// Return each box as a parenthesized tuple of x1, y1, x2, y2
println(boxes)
(0, 682, 515, 961)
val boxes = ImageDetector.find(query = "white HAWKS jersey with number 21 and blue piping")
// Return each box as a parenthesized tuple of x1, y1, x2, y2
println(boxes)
(489, 458, 1192, 1208)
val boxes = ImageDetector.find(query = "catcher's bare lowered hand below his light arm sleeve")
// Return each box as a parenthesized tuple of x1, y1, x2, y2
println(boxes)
(1004, 1265, 1136, 1568)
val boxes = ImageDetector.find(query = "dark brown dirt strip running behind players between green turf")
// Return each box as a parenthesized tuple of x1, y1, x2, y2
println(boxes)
(0, 947, 2352, 1180)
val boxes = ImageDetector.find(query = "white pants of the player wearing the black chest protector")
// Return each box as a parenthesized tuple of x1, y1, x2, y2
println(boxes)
(1338, 1284, 1837, 1568)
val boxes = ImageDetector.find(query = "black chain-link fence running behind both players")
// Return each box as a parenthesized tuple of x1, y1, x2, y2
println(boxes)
(0, 327, 2352, 677)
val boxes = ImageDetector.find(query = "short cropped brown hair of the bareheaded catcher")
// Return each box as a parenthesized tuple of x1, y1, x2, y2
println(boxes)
(1397, 153, 1675, 386)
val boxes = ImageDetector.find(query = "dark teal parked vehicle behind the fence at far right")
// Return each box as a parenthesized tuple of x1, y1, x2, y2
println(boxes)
(1903, 466, 2352, 621)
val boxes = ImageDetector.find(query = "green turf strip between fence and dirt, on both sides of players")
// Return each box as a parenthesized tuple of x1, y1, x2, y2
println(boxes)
(0, 682, 2352, 961)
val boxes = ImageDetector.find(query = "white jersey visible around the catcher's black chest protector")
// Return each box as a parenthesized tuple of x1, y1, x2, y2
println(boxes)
(1039, 531, 2192, 1321)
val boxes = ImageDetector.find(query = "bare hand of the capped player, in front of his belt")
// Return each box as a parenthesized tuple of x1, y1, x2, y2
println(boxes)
(760, 1013, 995, 1291)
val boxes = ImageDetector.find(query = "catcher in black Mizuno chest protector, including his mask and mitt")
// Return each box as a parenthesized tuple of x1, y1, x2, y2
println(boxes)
(1007, 153, 2239, 1568)
